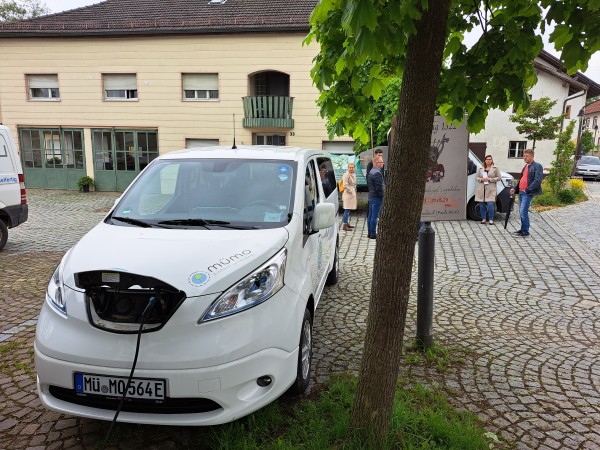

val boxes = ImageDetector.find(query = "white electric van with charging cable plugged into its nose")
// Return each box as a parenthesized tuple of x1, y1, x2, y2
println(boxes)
(35, 146, 339, 425)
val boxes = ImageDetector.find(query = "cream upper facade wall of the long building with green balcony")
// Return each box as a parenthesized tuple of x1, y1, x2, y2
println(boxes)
(0, 33, 338, 175)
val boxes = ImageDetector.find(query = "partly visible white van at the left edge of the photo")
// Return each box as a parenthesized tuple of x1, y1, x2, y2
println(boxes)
(0, 125, 29, 250)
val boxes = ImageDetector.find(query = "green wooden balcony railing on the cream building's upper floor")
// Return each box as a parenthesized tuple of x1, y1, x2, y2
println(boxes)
(242, 95, 294, 128)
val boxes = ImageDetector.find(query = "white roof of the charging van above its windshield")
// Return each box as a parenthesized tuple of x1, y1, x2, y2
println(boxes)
(159, 145, 329, 161)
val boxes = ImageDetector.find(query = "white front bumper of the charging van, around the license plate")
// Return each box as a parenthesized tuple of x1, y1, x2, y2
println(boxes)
(35, 346, 298, 426)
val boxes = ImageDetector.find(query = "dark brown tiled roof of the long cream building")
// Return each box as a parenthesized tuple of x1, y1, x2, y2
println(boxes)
(0, 0, 317, 37)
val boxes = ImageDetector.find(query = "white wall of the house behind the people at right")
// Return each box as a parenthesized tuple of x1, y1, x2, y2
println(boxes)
(469, 63, 585, 173)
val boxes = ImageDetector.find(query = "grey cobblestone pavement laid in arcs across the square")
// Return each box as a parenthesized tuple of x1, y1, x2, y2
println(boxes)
(0, 183, 600, 450)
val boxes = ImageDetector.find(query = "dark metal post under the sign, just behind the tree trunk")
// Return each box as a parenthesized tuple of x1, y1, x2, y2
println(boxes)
(417, 222, 435, 349)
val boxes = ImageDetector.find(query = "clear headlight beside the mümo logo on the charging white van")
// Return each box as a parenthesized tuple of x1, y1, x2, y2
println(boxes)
(198, 249, 287, 323)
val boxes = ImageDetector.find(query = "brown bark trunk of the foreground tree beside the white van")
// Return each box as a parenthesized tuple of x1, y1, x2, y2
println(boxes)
(351, 0, 450, 447)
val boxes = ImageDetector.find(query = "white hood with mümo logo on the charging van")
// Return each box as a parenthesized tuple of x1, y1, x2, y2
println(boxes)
(63, 223, 288, 297)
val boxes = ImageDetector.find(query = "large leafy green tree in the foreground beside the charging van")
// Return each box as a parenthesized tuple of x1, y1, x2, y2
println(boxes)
(307, 0, 600, 447)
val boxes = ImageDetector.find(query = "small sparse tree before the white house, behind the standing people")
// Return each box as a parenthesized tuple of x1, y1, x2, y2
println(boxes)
(510, 97, 565, 150)
